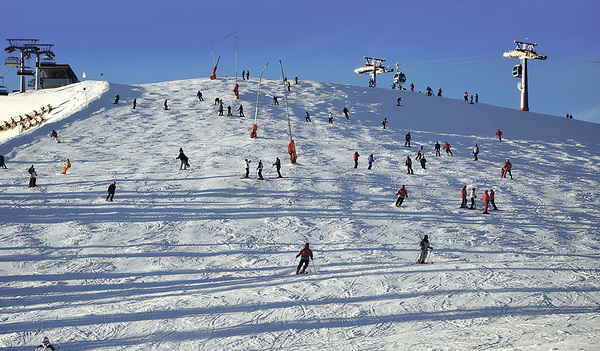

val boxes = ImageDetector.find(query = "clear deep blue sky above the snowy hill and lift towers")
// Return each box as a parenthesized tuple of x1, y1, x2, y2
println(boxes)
(0, 0, 600, 123)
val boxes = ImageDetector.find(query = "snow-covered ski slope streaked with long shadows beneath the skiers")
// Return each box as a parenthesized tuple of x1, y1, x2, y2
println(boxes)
(0, 78, 600, 351)
